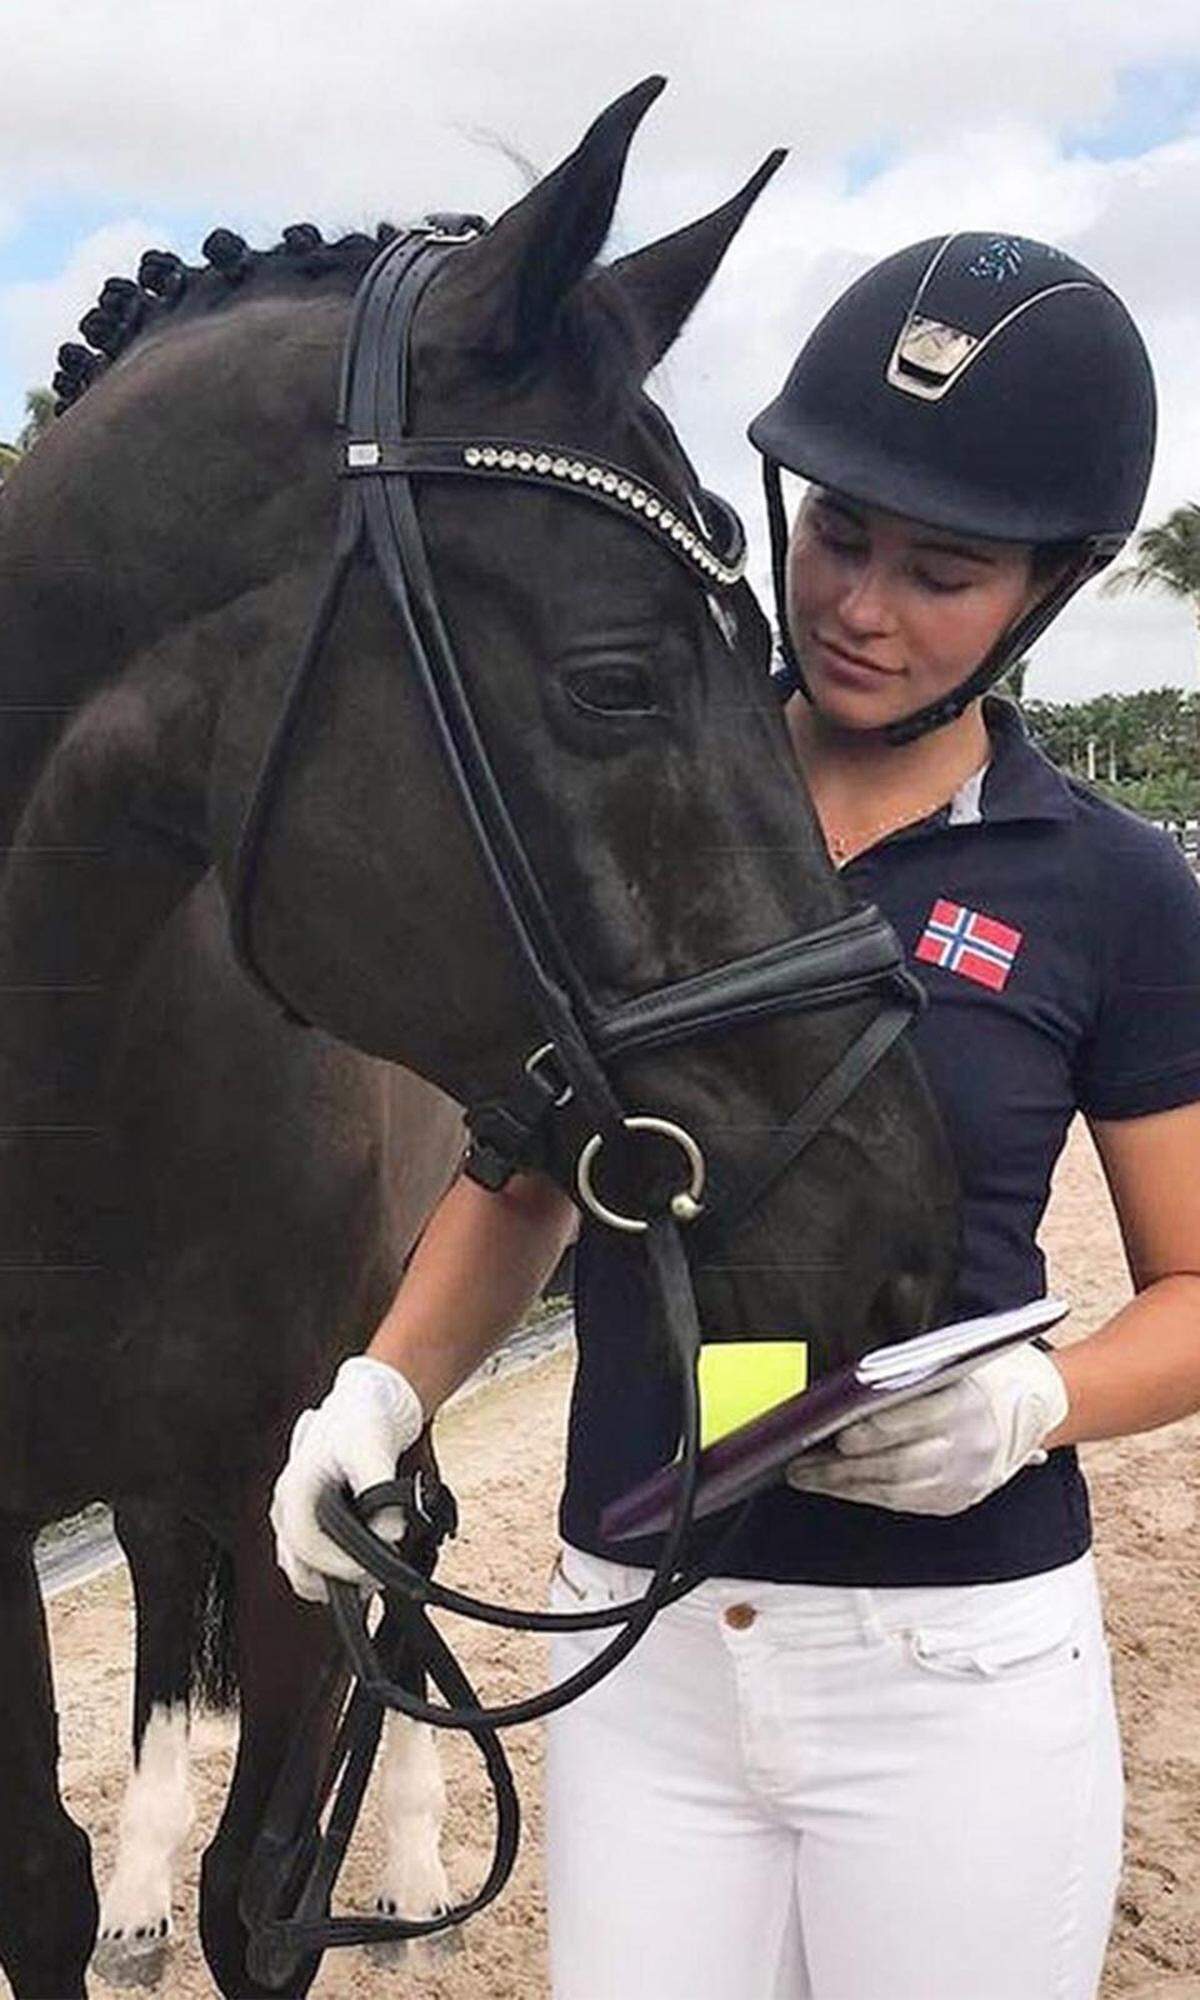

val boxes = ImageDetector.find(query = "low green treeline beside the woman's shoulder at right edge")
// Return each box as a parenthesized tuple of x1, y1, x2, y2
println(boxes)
(1024, 688, 1200, 820)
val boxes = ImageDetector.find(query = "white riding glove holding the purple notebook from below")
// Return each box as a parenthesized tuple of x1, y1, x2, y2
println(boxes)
(786, 1346, 1068, 1514)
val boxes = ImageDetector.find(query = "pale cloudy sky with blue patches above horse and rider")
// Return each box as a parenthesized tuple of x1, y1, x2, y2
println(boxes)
(0, 0, 1200, 702)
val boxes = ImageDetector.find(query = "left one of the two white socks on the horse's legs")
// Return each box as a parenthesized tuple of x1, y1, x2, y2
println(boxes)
(96, 1702, 196, 1984)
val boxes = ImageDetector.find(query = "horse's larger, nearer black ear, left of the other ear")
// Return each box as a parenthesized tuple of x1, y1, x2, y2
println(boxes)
(440, 76, 666, 356)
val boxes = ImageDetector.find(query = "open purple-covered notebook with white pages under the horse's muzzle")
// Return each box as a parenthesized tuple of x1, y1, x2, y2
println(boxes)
(600, 1298, 1070, 1542)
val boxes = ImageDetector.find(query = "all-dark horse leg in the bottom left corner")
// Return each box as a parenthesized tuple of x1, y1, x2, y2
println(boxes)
(0, 1524, 96, 2000)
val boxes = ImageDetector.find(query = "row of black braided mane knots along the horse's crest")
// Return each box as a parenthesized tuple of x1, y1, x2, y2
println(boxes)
(52, 222, 410, 416)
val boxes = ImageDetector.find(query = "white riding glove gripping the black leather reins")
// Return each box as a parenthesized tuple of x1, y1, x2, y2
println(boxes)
(270, 1354, 424, 1604)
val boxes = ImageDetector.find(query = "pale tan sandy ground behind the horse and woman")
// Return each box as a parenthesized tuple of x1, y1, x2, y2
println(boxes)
(9, 1126, 1200, 2000)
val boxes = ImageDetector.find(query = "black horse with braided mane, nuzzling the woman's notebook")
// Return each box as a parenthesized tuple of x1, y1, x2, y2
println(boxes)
(0, 82, 956, 2000)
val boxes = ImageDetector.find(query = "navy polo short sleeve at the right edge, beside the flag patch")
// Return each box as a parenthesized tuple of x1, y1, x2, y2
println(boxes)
(1076, 814, 1200, 1118)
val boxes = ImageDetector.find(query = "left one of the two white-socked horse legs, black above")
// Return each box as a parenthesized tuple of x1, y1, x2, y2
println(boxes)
(94, 1502, 214, 1986)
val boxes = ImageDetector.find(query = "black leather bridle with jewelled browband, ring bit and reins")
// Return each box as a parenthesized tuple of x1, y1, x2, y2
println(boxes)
(230, 218, 924, 1984)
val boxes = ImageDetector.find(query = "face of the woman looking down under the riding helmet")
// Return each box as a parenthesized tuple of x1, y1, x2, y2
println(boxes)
(788, 486, 1046, 730)
